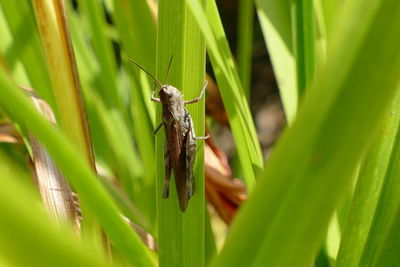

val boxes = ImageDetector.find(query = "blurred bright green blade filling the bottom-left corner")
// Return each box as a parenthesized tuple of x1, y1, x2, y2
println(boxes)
(0, 153, 108, 267)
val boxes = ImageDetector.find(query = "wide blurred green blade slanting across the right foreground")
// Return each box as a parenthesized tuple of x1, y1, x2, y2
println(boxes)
(212, 0, 400, 266)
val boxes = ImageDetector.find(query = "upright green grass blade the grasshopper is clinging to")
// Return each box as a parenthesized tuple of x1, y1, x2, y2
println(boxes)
(156, 0, 206, 267)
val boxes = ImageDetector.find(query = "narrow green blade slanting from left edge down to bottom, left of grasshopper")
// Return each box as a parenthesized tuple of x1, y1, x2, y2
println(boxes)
(0, 72, 153, 266)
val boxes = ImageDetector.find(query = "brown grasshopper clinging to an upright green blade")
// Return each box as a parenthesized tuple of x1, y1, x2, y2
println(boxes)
(130, 57, 209, 212)
